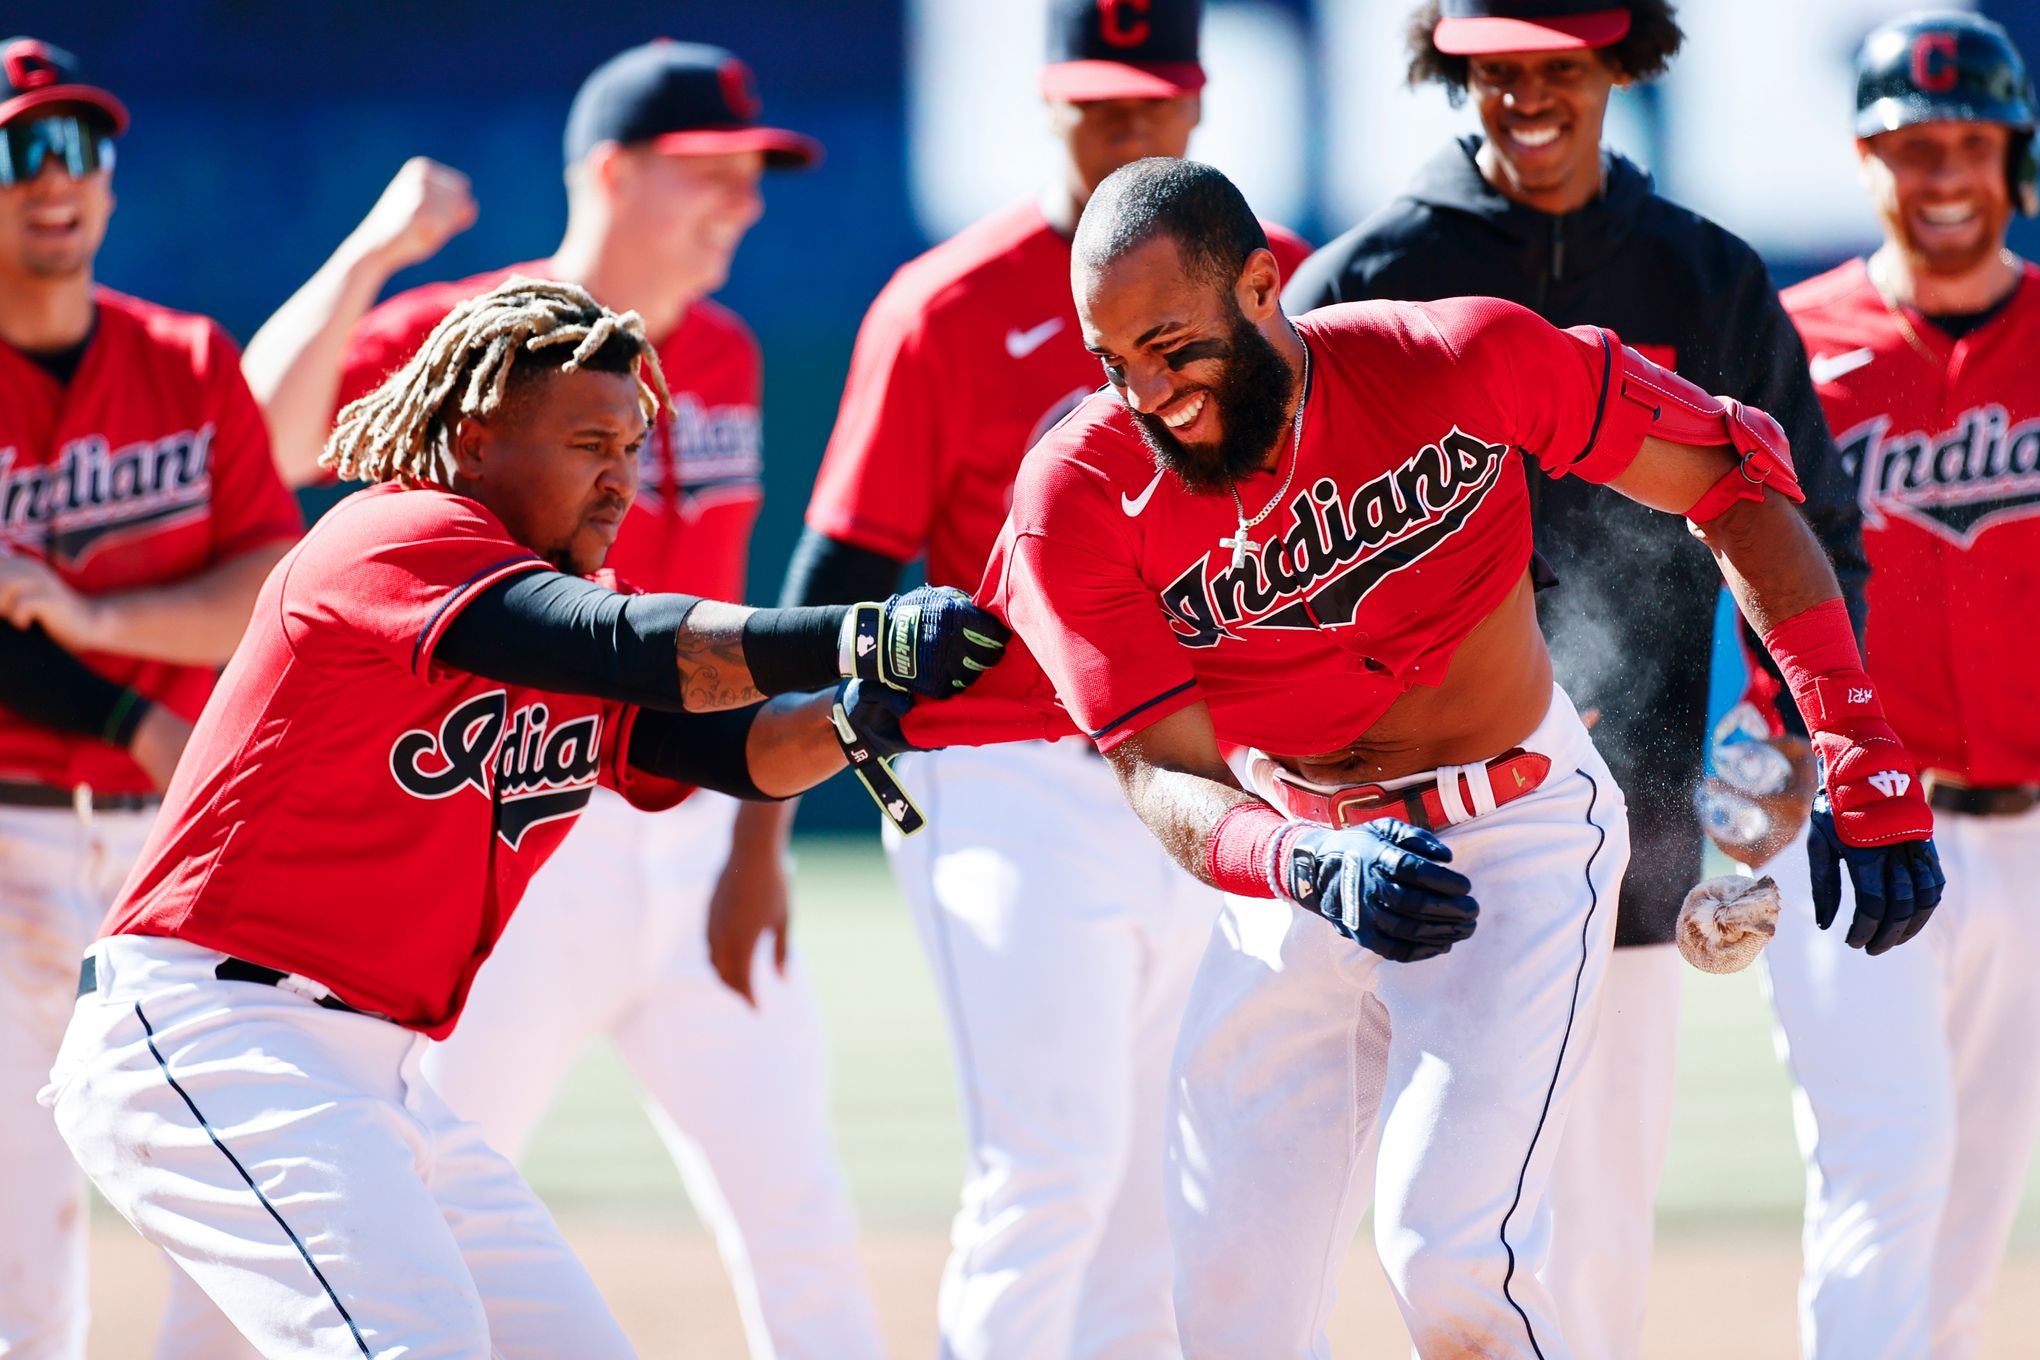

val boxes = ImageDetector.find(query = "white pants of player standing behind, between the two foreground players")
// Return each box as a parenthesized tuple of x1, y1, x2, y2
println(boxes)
(887, 740, 1220, 1360)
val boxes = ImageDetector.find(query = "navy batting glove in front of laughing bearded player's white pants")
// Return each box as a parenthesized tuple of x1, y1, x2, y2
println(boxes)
(1283, 818, 1481, 962)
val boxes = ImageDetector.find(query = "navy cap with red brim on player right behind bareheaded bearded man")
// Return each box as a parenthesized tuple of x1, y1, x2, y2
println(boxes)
(1040, 0, 1204, 104)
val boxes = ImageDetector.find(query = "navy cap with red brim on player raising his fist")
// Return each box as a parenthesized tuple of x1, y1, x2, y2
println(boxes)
(567, 39, 822, 169)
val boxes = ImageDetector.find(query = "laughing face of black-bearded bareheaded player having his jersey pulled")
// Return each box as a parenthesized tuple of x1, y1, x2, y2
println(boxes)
(1075, 234, 1295, 493)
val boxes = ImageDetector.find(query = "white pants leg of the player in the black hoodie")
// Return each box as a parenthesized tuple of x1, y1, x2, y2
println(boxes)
(1544, 944, 1685, 1360)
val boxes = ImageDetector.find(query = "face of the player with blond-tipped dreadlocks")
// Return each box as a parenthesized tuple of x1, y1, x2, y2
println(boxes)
(453, 360, 645, 575)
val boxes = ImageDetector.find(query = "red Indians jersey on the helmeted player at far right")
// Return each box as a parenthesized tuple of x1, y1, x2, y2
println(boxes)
(1783, 259, 2040, 785)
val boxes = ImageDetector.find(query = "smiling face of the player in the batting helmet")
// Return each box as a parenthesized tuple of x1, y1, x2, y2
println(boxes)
(1856, 122, 2011, 277)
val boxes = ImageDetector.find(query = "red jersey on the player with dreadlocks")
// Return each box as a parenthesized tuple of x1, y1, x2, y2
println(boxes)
(104, 483, 687, 1038)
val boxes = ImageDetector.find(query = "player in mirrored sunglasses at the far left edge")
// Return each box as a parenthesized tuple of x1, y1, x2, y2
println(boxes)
(0, 39, 302, 1358)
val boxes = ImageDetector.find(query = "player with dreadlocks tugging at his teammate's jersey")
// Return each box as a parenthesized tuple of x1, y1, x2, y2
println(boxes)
(43, 279, 1004, 1358)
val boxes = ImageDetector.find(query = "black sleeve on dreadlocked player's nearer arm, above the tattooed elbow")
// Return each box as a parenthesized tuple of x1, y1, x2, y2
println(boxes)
(435, 571, 700, 710)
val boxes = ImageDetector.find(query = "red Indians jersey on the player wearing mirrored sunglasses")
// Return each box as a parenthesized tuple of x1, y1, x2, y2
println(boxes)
(0, 287, 304, 793)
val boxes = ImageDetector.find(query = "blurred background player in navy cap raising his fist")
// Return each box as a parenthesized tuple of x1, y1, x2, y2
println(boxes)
(189, 41, 885, 1360)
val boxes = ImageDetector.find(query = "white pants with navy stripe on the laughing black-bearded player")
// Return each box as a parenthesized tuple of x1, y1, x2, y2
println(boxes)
(1169, 689, 1628, 1360)
